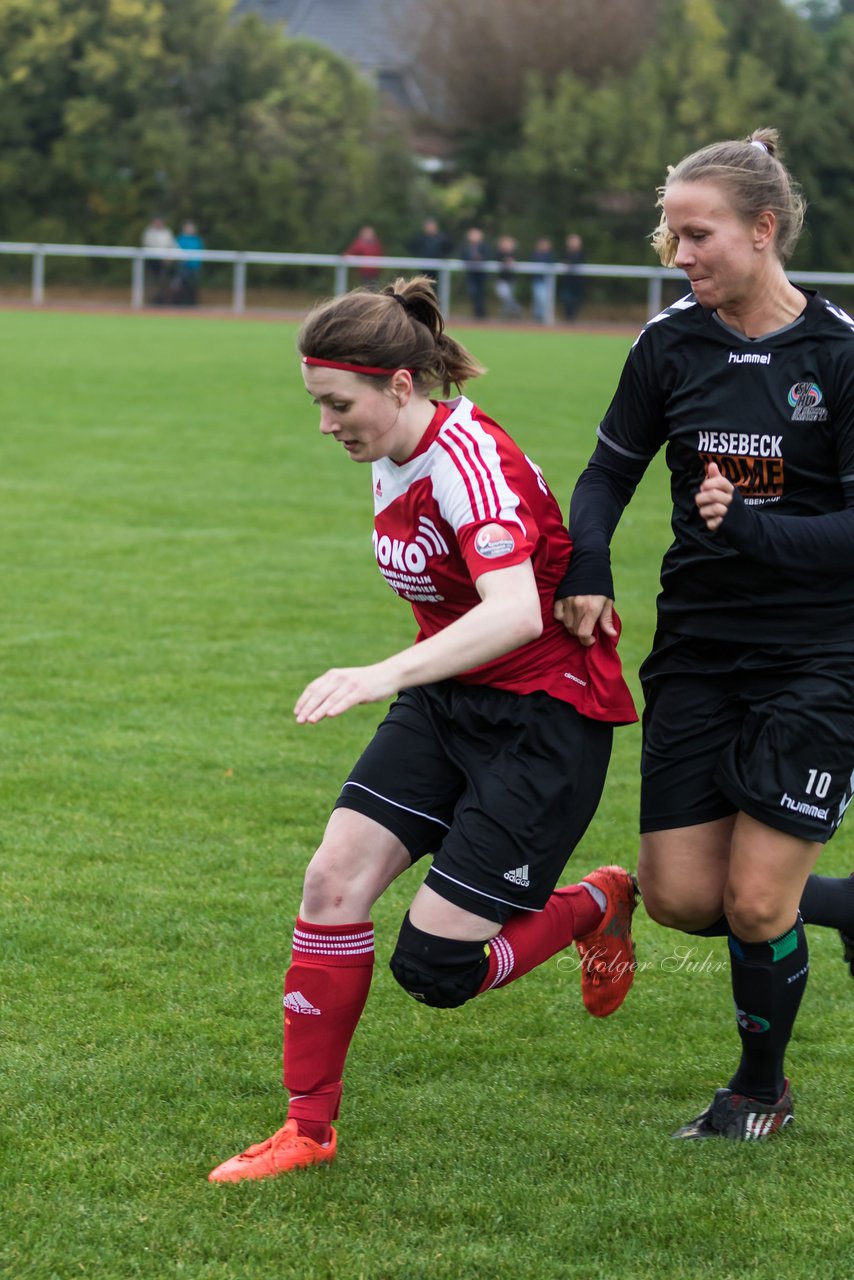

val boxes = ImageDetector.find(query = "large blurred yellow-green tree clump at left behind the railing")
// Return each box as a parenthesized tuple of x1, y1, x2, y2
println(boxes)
(0, 0, 407, 251)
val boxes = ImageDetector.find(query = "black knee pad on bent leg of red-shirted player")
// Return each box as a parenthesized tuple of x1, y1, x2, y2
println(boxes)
(389, 911, 489, 1009)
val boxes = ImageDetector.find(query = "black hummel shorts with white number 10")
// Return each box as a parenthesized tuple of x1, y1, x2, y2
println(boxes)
(640, 634, 854, 844)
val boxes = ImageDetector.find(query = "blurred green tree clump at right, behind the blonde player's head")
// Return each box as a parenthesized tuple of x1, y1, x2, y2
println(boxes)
(448, 0, 854, 268)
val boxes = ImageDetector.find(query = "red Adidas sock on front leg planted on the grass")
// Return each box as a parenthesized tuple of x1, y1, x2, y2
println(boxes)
(284, 916, 374, 1142)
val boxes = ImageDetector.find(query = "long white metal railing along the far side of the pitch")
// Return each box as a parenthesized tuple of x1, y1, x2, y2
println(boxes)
(0, 241, 854, 324)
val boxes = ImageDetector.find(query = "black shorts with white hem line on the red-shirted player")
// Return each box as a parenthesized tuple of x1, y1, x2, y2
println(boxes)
(335, 680, 613, 924)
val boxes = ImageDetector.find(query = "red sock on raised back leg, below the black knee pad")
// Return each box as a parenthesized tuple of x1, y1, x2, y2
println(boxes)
(478, 884, 602, 995)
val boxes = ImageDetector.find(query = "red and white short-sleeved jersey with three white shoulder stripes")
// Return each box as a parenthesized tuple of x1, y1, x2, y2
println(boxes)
(371, 396, 638, 724)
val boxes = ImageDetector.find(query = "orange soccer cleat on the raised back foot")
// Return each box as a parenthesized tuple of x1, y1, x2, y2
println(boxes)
(575, 867, 638, 1018)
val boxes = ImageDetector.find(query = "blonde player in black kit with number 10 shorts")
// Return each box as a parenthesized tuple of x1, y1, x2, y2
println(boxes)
(556, 129, 854, 1140)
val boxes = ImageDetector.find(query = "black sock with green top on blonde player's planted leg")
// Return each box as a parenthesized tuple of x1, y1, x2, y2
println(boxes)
(729, 916, 809, 1102)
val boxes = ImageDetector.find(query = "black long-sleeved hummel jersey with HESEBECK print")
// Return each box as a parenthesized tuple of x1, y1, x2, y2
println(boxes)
(558, 291, 854, 644)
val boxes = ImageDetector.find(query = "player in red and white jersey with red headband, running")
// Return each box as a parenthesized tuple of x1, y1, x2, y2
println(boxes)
(210, 278, 636, 1181)
